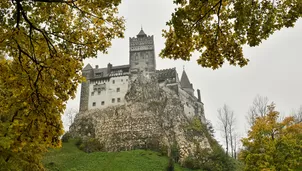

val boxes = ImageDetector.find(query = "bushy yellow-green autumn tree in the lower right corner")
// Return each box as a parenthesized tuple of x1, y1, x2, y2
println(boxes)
(240, 104, 302, 171)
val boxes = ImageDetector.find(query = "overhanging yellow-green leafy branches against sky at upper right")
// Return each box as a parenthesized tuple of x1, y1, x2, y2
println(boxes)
(161, 0, 302, 69)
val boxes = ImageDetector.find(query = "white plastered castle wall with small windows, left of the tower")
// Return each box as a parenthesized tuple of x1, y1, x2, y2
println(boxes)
(88, 76, 129, 110)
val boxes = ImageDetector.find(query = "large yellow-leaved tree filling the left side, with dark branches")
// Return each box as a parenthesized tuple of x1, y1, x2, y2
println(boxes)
(0, 0, 124, 170)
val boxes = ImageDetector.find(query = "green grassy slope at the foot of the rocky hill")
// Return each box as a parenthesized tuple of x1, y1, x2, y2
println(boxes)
(43, 141, 198, 171)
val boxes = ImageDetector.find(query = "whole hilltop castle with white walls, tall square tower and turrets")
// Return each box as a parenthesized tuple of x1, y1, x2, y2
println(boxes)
(80, 29, 205, 122)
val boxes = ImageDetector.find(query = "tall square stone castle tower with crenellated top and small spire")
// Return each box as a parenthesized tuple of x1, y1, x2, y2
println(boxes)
(129, 29, 156, 75)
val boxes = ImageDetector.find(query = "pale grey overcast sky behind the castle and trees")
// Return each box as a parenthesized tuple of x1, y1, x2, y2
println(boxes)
(67, 0, 302, 146)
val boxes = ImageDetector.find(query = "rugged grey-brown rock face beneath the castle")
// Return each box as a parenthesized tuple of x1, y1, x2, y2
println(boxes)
(70, 76, 210, 161)
